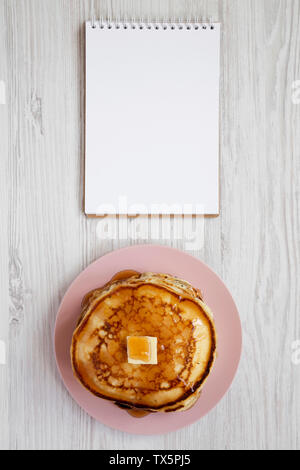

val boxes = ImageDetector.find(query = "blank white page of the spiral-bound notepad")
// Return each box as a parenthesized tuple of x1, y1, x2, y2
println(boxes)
(85, 23, 220, 215)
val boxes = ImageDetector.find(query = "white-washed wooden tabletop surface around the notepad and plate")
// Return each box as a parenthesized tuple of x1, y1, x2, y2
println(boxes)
(0, 0, 300, 449)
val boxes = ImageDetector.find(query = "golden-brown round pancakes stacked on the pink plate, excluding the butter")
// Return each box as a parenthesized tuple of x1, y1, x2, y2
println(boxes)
(71, 273, 216, 411)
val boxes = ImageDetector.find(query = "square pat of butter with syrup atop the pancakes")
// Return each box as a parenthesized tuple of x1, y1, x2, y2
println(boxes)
(127, 336, 157, 364)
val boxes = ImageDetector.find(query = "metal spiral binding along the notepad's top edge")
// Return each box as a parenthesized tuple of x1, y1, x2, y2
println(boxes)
(90, 17, 215, 31)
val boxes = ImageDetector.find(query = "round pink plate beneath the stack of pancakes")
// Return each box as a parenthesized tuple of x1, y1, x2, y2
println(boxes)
(55, 245, 242, 434)
